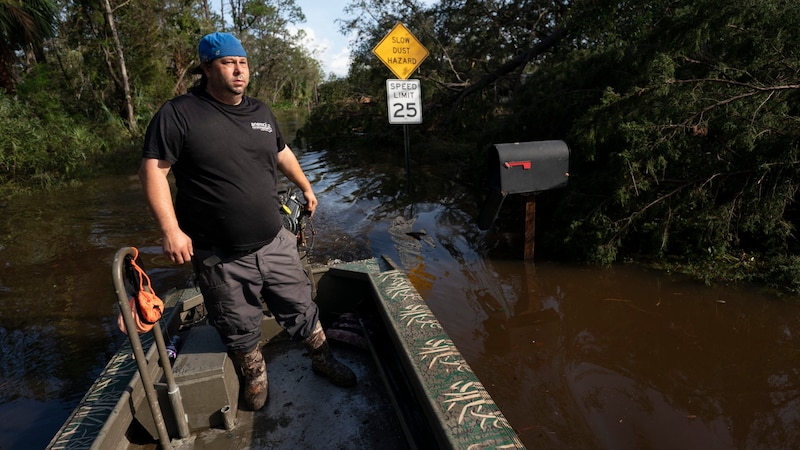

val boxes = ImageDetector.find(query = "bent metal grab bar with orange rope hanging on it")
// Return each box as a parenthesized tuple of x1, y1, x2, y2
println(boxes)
(111, 247, 189, 449)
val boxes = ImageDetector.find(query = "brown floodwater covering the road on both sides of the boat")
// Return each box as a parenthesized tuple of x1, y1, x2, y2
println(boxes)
(0, 140, 800, 449)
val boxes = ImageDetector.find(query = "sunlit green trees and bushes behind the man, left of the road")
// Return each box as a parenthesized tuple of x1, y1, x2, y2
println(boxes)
(0, 0, 321, 194)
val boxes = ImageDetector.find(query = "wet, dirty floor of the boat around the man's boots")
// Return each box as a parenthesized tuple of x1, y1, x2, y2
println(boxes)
(128, 338, 409, 450)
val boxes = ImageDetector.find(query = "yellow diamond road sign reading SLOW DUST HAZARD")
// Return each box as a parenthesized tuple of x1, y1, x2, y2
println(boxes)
(372, 22, 428, 80)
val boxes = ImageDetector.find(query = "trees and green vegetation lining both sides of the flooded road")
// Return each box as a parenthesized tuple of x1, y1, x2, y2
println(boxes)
(0, 0, 800, 292)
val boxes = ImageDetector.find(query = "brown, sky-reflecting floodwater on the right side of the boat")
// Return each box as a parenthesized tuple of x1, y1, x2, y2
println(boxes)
(309, 146, 800, 449)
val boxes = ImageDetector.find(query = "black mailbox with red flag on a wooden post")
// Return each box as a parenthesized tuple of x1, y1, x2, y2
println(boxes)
(488, 141, 569, 194)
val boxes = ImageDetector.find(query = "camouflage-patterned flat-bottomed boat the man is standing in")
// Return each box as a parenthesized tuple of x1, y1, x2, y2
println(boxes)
(48, 259, 524, 450)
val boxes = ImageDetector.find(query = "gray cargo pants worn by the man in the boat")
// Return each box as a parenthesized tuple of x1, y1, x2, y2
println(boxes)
(192, 227, 319, 352)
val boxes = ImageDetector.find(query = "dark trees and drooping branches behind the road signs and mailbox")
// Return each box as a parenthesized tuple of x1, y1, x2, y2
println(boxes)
(313, 0, 800, 287)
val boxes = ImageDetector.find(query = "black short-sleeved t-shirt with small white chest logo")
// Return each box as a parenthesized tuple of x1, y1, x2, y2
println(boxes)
(142, 89, 285, 251)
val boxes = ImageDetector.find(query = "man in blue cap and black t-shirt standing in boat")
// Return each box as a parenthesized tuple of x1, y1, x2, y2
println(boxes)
(139, 32, 356, 410)
